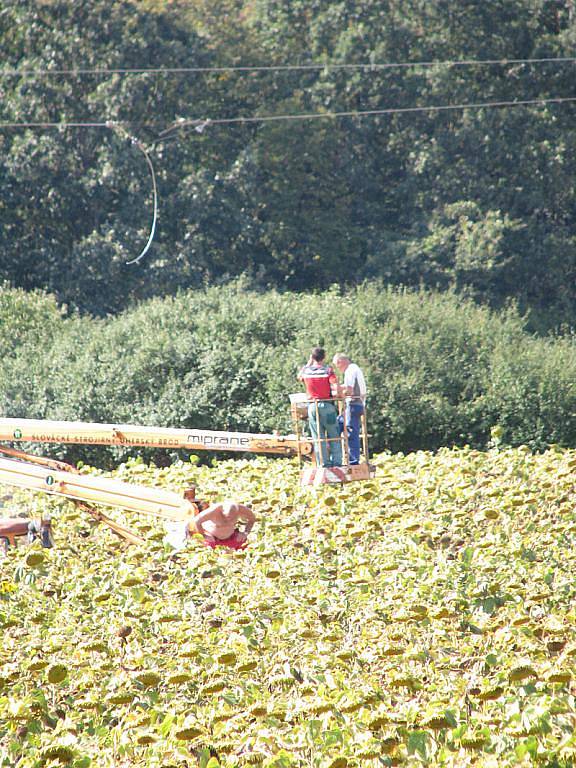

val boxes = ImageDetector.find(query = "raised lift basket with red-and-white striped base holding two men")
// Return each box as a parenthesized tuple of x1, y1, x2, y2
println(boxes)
(290, 392, 375, 485)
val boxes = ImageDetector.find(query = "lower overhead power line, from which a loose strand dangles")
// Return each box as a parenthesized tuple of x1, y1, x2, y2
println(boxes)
(0, 96, 576, 135)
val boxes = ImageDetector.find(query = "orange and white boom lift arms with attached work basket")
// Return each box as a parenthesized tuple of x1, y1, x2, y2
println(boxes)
(0, 402, 373, 546)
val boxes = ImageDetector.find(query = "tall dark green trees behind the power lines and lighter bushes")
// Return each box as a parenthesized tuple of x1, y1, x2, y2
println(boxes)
(0, 0, 576, 329)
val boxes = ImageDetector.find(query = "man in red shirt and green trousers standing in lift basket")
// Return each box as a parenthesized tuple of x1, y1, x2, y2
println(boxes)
(298, 347, 342, 467)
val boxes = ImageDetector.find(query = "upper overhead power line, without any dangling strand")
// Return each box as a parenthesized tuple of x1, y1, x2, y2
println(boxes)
(0, 56, 576, 77)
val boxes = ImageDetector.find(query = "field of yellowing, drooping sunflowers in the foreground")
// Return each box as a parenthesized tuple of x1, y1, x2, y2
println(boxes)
(0, 448, 576, 768)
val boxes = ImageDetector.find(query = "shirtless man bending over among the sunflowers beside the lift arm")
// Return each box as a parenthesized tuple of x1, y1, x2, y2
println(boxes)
(190, 501, 256, 549)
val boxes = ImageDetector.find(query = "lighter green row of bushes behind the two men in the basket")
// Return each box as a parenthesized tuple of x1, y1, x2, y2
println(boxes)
(0, 283, 576, 461)
